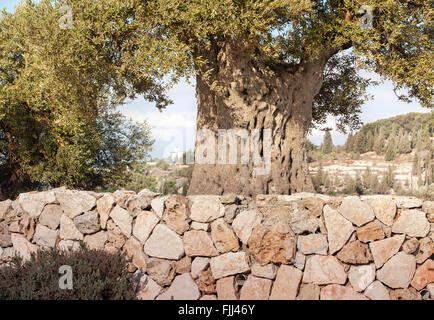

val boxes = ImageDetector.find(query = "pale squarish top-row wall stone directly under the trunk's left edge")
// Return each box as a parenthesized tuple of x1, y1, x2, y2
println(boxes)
(188, 195, 225, 222)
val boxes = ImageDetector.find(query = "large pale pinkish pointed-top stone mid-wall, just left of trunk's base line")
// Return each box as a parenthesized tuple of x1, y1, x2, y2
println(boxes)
(144, 224, 184, 260)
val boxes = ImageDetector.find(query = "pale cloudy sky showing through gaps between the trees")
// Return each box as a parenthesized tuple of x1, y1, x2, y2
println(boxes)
(0, 0, 429, 158)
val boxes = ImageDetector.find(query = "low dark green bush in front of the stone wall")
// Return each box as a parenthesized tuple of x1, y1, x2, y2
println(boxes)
(0, 246, 135, 300)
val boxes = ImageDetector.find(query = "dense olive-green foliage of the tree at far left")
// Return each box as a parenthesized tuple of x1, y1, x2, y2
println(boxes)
(0, 0, 157, 196)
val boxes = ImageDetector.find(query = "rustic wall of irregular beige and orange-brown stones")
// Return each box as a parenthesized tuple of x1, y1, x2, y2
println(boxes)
(0, 188, 434, 300)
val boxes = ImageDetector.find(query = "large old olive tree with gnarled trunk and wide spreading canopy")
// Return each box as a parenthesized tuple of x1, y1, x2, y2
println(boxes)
(1, 0, 434, 195)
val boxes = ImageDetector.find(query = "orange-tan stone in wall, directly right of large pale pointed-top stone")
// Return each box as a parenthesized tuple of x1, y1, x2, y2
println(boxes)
(183, 230, 218, 257)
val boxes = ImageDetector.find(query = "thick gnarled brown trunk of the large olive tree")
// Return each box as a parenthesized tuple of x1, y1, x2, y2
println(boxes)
(188, 42, 326, 196)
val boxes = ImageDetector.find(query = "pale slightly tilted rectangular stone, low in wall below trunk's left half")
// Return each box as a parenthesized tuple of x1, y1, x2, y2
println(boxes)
(210, 252, 250, 279)
